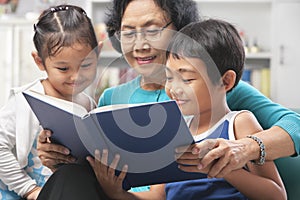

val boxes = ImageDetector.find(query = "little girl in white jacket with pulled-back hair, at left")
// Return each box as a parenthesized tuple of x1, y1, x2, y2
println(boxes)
(0, 5, 98, 200)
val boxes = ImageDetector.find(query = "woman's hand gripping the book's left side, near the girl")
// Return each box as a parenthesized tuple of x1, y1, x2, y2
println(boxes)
(37, 130, 76, 171)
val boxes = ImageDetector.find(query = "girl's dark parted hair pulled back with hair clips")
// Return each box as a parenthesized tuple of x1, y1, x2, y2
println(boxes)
(33, 5, 98, 62)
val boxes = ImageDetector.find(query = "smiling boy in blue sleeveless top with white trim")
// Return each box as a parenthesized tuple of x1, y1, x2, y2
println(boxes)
(89, 20, 286, 200)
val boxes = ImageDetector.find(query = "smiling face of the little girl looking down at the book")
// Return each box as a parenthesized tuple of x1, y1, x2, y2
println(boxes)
(43, 43, 97, 100)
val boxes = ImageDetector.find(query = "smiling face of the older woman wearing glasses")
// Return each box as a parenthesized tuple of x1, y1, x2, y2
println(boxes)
(121, 0, 175, 77)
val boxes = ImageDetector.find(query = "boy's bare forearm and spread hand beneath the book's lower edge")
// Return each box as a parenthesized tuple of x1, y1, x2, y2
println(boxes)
(87, 150, 165, 200)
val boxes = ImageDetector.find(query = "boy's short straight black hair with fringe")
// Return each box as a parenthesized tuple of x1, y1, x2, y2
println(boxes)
(167, 19, 245, 90)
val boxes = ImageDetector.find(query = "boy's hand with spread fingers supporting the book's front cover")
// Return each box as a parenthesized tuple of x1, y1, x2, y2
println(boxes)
(87, 149, 128, 199)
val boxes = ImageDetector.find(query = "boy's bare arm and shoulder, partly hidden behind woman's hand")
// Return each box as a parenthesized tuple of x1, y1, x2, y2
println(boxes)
(224, 112, 287, 199)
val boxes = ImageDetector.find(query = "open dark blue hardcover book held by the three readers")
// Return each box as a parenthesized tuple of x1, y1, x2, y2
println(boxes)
(23, 91, 206, 189)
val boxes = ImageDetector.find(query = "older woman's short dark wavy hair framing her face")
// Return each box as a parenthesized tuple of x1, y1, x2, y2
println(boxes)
(106, 0, 200, 52)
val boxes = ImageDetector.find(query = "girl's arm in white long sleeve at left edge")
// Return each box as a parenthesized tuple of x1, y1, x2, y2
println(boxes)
(0, 95, 38, 196)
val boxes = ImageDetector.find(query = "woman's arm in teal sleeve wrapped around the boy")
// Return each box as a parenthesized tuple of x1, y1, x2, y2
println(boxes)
(227, 81, 300, 157)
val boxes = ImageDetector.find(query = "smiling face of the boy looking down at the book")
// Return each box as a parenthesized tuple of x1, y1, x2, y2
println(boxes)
(165, 55, 218, 115)
